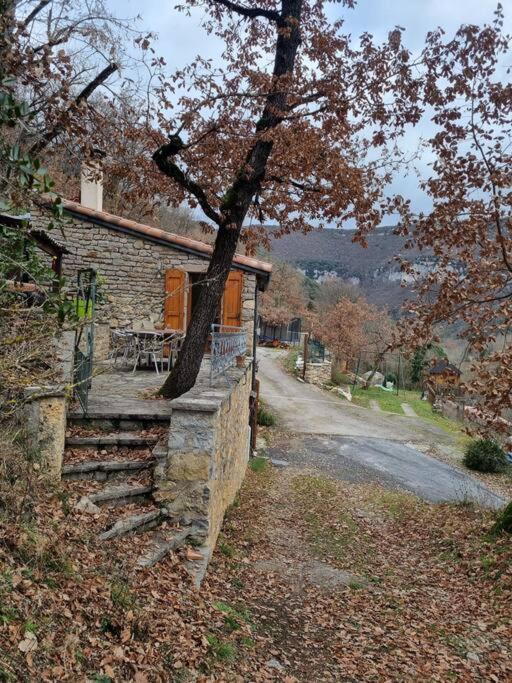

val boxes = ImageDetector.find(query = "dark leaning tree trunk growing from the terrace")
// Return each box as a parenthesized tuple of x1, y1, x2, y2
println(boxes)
(158, 0, 303, 399)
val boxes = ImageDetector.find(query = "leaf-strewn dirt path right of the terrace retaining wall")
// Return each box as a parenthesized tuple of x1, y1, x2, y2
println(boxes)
(202, 460, 512, 683)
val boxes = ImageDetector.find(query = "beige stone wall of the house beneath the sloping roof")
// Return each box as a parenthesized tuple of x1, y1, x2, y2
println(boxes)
(32, 212, 256, 353)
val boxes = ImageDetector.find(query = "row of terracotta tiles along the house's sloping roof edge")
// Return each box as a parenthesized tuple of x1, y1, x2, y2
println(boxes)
(62, 199, 272, 276)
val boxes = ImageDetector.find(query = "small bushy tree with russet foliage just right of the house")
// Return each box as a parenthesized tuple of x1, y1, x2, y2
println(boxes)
(259, 263, 306, 325)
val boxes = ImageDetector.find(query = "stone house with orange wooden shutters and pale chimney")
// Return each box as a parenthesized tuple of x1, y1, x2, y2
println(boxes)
(31, 174, 272, 358)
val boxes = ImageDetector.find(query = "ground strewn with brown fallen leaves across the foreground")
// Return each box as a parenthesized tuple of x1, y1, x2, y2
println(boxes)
(0, 454, 512, 683)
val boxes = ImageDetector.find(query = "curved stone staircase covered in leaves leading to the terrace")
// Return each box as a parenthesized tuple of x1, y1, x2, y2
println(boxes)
(62, 413, 202, 573)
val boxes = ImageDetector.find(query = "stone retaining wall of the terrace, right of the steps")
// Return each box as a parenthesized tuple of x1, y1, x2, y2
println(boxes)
(155, 363, 251, 557)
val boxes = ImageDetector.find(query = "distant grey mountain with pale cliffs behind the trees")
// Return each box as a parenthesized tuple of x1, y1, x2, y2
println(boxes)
(266, 227, 431, 316)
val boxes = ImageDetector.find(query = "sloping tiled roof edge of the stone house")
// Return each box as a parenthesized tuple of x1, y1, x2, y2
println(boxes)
(57, 199, 272, 285)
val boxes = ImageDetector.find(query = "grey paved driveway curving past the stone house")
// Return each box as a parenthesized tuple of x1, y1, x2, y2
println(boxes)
(258, 349, 504, 508)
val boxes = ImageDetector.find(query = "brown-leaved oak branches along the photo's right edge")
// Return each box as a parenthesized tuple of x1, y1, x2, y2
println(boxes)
(399, 7, 512, 430)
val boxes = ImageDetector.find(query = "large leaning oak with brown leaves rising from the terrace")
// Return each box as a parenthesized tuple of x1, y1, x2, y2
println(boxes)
(153, 0, 420, 398)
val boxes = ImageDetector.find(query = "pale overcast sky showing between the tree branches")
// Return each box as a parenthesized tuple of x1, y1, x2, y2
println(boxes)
(108, 0, 512, 224)
